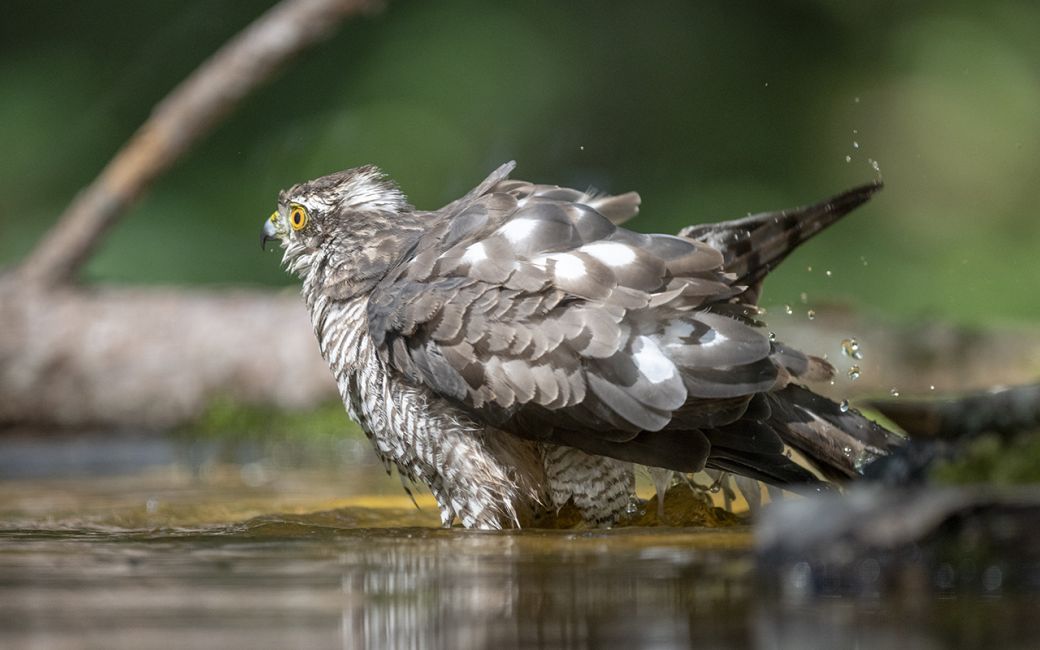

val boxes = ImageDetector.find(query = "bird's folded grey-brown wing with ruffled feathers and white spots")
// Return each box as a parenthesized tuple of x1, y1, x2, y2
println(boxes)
(367, 174, 827, 470)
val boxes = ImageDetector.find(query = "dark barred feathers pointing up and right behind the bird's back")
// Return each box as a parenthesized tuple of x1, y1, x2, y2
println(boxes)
(679, 181, 883, 286)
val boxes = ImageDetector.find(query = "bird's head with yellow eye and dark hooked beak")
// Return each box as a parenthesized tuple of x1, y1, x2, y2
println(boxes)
(260, 165, 416, 299)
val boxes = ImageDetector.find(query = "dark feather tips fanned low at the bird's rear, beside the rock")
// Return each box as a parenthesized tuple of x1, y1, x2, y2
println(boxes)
(769, 384, 905, 479)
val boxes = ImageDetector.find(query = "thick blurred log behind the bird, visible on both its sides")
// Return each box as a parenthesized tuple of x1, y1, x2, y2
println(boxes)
(0, 293, 1040, 427)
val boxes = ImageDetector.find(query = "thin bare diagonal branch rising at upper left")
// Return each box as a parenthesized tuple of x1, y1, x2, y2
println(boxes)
(17, 0, 379, 287)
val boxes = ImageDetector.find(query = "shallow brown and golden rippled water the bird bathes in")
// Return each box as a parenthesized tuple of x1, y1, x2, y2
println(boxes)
(0, 428, 1040, 648)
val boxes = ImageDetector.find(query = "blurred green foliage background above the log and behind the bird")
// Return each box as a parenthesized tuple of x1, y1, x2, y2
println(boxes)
(0, 0, 1040, 323)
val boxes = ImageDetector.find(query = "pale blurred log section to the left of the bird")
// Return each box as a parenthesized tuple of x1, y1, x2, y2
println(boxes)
(0, 285, 336, 428)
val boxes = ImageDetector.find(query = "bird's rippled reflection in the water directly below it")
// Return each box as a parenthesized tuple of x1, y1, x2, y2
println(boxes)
(330, 534, 749, 648)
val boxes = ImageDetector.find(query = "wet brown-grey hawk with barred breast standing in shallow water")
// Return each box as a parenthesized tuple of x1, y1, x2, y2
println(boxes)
(261, 162, 899, 528)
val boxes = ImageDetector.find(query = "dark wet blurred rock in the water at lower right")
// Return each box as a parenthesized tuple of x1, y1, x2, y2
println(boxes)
(756, 487, 1040, 598)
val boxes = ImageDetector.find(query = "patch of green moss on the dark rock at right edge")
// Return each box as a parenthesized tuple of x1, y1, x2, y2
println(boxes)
(931, 434, 1040, 485)
